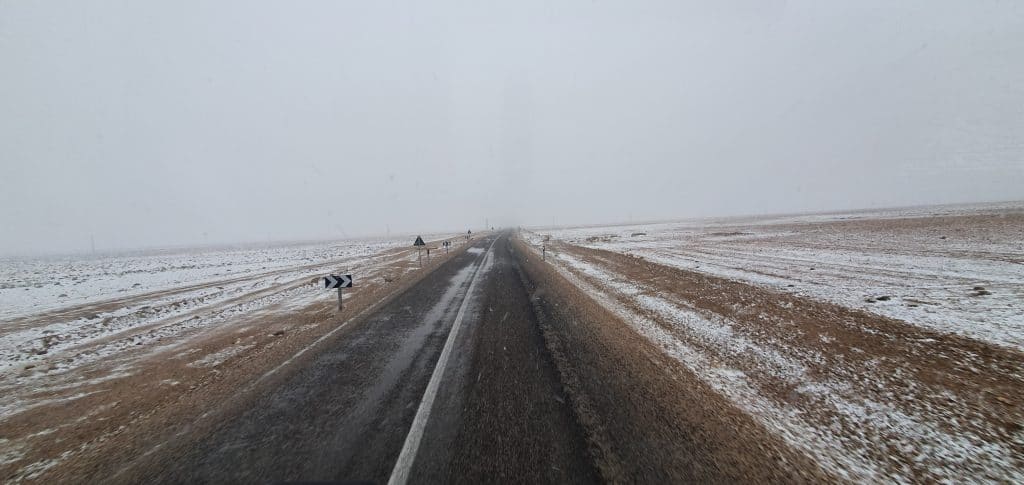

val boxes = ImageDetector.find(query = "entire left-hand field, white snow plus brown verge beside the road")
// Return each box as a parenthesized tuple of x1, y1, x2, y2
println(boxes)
(0, 234, 462, 482)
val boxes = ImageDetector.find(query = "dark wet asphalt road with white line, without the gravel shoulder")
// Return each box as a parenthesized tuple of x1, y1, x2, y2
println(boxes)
(119, 234, 597, 483)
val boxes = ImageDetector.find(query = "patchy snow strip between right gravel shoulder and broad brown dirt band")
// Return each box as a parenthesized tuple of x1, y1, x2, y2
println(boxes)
(526, 234, 1024, 482)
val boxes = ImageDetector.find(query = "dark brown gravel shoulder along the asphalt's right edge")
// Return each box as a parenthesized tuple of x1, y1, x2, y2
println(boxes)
(507, 237, 835, 483)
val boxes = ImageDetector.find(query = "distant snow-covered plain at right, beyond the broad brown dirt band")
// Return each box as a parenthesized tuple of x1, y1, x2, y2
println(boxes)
(539, 203, 1024, 350)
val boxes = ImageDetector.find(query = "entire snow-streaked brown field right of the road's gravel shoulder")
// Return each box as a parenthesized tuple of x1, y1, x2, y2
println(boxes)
(522, 204, 1024, 483)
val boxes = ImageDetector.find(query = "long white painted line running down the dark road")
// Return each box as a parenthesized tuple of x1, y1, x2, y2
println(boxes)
(387, 237, 501, 485)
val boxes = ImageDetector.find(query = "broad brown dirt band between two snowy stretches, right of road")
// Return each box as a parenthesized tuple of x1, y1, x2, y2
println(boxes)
(549, 236, 1024, 479)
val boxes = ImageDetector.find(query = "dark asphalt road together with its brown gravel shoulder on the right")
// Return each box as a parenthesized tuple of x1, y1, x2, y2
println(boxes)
(104, 232, 824, 483)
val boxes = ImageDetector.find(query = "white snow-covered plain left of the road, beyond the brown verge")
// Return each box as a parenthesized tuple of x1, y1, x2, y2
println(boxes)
(0, 233, 456, 407)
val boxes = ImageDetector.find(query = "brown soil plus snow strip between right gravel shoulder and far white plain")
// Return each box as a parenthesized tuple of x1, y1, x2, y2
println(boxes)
(530, 236, 1024, 480)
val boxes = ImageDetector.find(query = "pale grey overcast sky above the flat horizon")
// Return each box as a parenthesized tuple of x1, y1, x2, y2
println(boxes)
(0, 0, 1024, 254)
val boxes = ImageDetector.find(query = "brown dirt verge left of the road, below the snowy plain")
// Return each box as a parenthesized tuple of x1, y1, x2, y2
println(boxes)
(0, 236, 466, 483)
